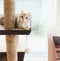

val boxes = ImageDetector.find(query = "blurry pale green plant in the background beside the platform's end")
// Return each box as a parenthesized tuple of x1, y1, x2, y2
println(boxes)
(32, 21, 45, 35)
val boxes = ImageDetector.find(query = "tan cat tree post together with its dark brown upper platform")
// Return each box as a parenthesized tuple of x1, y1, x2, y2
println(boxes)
(0, 0, 31, 61)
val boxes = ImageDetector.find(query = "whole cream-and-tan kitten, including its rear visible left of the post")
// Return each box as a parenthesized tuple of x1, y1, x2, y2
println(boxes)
(0, 10, 31, 30)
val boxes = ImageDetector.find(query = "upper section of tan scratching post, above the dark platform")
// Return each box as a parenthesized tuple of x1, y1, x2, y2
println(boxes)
(4, 0, 15, 30)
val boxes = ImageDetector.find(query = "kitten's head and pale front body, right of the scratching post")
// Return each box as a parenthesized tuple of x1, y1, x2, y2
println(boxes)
(18, 10, 31, 30)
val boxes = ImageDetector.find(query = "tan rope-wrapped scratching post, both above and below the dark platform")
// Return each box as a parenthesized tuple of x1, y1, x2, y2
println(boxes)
(4, 0, 18, 61)
